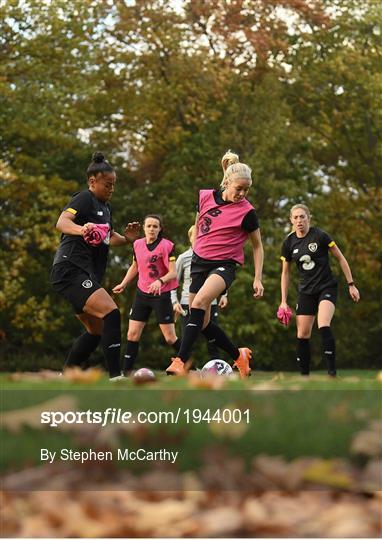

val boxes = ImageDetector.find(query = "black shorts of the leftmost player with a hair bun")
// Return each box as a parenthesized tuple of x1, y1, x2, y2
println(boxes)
(50, 263, 102, 315)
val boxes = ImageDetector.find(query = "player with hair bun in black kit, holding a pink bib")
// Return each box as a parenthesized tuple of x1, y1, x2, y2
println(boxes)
(51, 152, 139, 380)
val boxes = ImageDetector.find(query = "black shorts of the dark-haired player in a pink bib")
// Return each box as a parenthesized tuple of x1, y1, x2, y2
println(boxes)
(129, 289, 174, 324)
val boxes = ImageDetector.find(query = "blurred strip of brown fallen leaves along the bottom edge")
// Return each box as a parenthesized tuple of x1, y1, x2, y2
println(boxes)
(1, 476, 382, 538)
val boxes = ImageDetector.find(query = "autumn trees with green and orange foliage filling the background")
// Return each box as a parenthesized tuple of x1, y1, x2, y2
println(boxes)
(0, 0, 382, 369)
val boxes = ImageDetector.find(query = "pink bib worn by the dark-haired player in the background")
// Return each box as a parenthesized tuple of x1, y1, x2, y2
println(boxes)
(134, 238, 178, 293)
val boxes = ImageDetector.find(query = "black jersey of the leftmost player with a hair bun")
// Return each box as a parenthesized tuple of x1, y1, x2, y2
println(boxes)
(53, 190, 113, 281)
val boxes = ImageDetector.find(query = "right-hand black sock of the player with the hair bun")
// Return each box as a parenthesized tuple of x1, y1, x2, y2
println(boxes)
(101, 308, 121, 377)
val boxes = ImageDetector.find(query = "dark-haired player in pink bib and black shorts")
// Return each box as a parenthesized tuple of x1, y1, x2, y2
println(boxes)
(113, 214, 179, 374)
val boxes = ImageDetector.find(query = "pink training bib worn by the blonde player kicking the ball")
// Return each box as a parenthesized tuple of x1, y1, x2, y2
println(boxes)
(194, 189, 253, 264)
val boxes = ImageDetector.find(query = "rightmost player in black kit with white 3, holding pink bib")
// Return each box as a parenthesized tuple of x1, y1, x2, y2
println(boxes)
(279, 204, 360, 377)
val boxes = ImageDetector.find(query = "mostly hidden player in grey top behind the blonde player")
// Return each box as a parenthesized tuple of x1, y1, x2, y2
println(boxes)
(171, 225, 228, 360)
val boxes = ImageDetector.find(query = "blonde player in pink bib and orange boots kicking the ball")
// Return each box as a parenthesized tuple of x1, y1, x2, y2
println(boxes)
(166, 152, 264, 377)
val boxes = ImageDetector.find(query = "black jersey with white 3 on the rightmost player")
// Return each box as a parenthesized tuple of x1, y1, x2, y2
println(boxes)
(281, 227, 337, 294)
